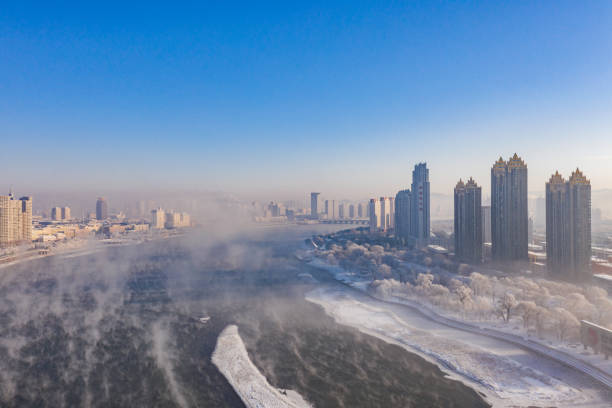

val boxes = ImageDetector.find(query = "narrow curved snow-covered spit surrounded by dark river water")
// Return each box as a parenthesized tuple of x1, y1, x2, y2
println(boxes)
(212, 325, 311, 408)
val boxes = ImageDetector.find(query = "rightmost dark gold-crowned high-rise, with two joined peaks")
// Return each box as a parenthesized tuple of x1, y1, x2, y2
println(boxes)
(546, 169, 591, 280)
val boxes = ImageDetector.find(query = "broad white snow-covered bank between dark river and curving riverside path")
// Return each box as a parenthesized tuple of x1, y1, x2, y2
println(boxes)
(307, 285, 609, 407)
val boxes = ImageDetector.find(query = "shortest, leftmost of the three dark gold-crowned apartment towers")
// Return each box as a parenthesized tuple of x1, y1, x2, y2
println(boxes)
(455, 177, 482, 263)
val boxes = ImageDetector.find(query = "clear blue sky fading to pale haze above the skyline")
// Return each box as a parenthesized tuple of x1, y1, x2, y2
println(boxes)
(0, 0, 612, 196)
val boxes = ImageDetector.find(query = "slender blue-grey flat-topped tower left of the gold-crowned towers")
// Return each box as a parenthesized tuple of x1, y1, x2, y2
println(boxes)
(410, 163, 430, 245)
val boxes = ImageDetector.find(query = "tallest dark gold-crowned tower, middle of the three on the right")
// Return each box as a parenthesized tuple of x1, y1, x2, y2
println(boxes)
(491, 153, 529, 261)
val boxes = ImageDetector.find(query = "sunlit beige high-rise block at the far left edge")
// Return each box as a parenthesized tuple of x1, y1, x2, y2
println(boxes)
(0, 193, 32, 247)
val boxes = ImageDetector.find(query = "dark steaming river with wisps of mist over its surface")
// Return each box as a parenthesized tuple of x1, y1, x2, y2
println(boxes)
(0, 227, 485, 407)
